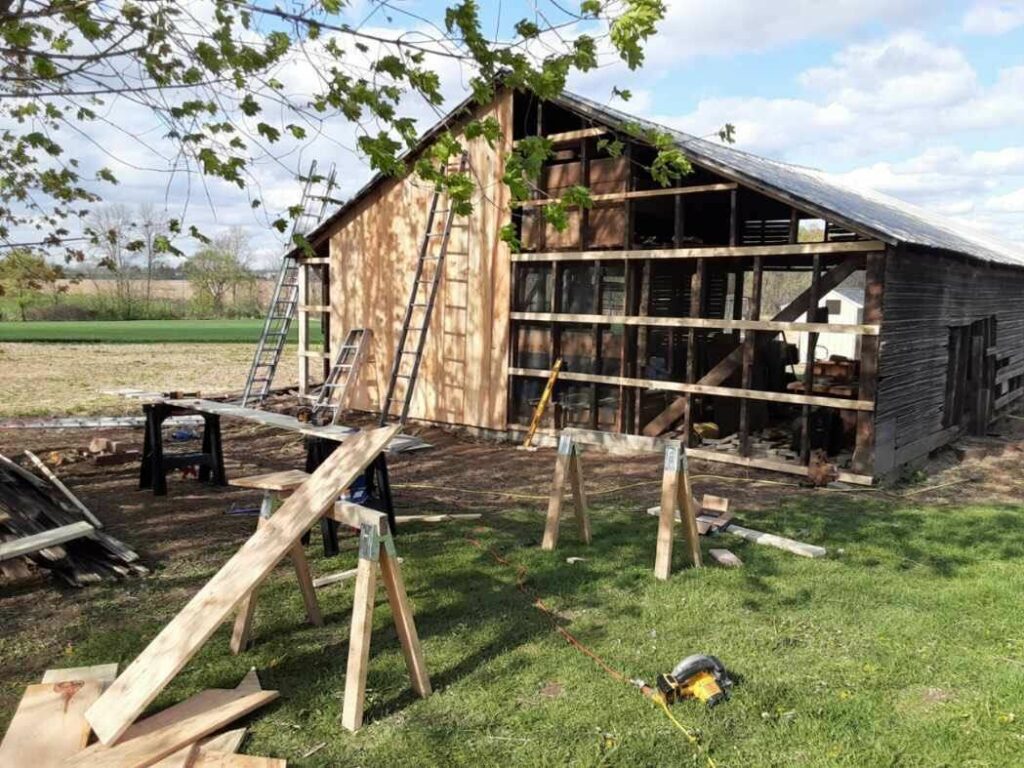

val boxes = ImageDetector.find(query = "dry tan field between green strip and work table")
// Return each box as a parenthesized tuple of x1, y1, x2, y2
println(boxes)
(0, 343, 298, 419)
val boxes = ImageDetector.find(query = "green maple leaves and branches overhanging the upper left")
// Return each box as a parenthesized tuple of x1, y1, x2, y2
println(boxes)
(0, 0, 686, 259)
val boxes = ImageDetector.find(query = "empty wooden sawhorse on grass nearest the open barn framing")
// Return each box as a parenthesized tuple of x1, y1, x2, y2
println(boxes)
(541, 429, 701, 581)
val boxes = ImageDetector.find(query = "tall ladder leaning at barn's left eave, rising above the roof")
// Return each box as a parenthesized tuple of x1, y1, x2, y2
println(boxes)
(242, 160, 341, 408)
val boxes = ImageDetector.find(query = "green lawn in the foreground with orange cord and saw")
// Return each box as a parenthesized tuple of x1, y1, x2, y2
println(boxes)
(0, 494, 1024, 768)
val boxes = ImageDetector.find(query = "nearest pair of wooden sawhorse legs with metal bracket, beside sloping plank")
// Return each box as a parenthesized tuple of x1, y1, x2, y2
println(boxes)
(341, 514, 431, 731)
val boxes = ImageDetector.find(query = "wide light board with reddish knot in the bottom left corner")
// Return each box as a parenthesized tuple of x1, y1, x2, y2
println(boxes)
(0, 680, 102, 768)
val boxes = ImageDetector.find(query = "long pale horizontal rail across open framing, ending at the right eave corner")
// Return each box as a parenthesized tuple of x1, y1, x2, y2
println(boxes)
(512, 240, 886, 261)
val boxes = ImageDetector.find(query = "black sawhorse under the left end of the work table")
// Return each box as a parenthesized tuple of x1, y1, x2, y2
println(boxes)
(138, 402, 227, 496)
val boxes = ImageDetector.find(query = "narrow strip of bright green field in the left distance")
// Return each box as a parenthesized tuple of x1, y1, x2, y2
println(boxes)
(0, 318, 319, 344)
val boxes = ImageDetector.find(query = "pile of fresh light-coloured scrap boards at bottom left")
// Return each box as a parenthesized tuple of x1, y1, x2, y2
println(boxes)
(0, 664, 287, 768)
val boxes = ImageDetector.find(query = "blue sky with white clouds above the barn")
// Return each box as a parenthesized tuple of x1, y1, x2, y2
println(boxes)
(16, 0, 1024, 266)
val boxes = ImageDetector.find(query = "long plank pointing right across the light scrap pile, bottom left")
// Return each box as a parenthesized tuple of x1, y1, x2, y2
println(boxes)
(65, 688, 278, 768)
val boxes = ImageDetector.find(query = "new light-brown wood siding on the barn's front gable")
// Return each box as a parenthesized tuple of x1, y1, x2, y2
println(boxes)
(331, 93, 512, 429)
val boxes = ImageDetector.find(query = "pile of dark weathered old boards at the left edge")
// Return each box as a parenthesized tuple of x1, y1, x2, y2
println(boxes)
(0, 453, 148, 587)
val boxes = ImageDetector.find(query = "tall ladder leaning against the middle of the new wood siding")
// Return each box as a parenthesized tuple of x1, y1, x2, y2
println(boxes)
(380, 153, 469, 426)
